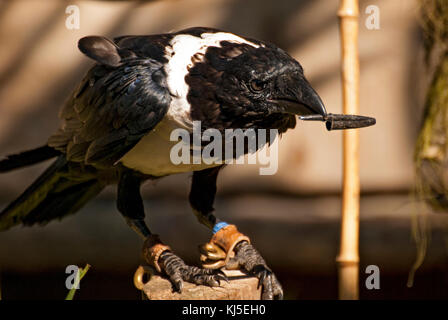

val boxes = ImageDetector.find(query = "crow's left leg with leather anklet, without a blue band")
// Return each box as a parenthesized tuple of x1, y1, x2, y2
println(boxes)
(117, 170, 227, 292)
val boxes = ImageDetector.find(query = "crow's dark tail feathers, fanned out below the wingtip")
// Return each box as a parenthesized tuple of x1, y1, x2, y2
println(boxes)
(0, 155, 104, 231)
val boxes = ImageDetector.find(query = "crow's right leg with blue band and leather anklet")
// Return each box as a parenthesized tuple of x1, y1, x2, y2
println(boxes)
(190, 168, 283, 300)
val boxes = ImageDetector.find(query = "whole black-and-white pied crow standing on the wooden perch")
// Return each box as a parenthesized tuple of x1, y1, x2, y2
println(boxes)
(0, 27, 326, 299)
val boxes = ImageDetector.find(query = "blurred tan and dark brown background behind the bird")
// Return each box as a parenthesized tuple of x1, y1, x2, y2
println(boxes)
(0, 0, 448, 299)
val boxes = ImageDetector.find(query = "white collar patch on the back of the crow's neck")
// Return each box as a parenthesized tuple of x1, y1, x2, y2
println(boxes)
(165, 32, 260, 123)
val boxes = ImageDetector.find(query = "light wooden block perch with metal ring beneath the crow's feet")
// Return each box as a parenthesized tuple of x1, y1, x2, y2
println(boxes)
(134, 266, 261, 300)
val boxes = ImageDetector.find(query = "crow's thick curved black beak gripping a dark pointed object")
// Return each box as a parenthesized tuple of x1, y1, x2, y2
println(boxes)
(274, 78, 327, 117)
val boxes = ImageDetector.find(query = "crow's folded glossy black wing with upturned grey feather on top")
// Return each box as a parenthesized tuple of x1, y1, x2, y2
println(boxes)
(48, 37, 171, 167)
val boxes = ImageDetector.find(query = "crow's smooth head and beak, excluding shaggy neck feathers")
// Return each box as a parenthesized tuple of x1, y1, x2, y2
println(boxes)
(217, 43, 326, 115)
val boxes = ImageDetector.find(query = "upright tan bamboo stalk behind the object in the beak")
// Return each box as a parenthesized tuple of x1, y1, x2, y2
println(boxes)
(336, 0, 360, 300)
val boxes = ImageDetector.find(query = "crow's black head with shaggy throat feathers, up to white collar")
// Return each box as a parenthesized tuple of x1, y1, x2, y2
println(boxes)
(181, 30, 326, 127)
